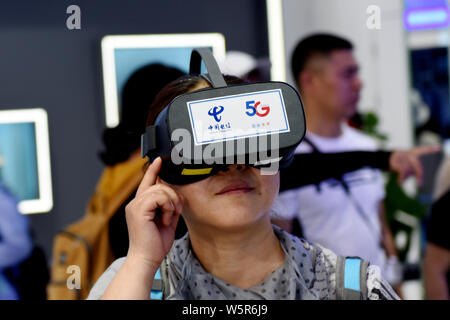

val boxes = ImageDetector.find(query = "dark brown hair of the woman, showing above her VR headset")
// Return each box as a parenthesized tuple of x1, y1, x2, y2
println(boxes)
(147, 75, 246, 126)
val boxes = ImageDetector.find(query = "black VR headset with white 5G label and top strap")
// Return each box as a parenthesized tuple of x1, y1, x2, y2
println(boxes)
(141, 48, 306, 185)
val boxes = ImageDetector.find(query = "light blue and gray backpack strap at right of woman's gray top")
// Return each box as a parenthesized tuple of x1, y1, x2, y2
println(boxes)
(336, 256, 369, 300)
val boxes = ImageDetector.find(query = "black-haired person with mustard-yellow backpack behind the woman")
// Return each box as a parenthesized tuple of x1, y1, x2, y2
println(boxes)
(48, 63, 186, 300)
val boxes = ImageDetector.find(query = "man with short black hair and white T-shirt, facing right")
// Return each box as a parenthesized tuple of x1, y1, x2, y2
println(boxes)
(278, 34, 402, 293)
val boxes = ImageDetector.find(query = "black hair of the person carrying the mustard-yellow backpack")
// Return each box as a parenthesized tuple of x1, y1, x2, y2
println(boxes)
(100, 63, 184, 166)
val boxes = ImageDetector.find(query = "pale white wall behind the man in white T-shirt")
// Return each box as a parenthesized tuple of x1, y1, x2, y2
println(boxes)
(274, 0, 413, 148)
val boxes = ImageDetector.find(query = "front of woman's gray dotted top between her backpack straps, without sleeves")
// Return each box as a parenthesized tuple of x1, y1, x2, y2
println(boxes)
(161, 226, 335, 300)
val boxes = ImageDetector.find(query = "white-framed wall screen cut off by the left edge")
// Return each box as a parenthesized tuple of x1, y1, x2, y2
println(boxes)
(0, 108, 53, 214)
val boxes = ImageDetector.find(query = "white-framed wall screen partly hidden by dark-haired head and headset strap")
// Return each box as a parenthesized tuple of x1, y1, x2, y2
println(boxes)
(101, 33, 225, 127)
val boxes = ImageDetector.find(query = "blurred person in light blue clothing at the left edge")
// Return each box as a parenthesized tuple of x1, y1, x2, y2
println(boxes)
(0, 153, 32, 300)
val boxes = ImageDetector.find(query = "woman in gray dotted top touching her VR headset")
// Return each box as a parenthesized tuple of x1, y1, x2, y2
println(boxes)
(89, 76, 406, 300)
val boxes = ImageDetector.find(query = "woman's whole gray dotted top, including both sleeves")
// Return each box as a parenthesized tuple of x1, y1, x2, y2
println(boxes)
(88, 226, 399, 300)
